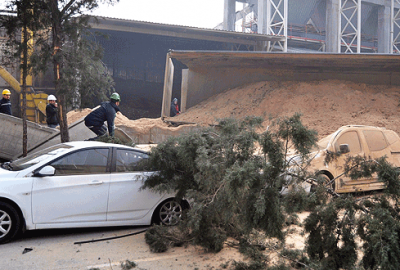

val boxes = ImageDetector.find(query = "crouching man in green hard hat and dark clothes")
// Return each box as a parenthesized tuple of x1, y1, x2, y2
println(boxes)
(85, 93, 121, 140)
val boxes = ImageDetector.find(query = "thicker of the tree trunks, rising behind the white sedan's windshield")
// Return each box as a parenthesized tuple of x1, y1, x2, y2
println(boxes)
(50, 0, 69, 142)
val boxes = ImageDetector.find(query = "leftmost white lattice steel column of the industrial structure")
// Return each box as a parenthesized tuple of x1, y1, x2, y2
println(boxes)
(266, 0, 288, 52)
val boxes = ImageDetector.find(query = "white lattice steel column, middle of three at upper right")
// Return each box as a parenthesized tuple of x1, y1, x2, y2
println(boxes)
(338, 0, 360, 53)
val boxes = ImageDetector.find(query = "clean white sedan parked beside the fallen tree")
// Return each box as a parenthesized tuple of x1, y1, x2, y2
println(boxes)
(0, 141, 188, 243)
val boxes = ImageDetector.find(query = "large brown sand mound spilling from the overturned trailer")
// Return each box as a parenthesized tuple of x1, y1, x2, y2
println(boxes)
(170, 80, 400, 136)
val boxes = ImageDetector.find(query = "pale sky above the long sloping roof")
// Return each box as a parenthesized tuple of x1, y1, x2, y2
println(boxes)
(91, 0, 228, 28)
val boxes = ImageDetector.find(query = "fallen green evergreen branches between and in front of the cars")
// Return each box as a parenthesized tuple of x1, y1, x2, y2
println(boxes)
(143, 114, 400, 269)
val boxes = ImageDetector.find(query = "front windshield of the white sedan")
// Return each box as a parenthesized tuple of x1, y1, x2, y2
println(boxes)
(8, 144, 72, 171)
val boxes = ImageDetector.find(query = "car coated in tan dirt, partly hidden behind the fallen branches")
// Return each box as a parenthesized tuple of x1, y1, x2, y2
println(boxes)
(296, 125, 400, 193)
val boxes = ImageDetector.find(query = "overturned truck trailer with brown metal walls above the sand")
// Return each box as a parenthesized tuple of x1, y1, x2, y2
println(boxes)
(161, 51, 400, 117)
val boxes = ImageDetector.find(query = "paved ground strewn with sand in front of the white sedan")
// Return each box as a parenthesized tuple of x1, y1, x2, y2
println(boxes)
(0, 227, 240, 270)
